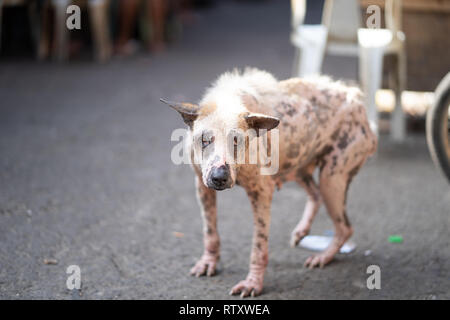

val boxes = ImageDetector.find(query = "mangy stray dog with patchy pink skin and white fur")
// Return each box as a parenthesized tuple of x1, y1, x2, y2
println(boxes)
(161, 69, 377, 297)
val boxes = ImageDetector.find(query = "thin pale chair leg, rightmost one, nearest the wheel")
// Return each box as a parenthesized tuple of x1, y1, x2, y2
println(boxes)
(391, 51, 406, 142)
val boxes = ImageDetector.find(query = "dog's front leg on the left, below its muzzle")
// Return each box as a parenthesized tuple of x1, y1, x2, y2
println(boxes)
(191, 176, 220, 277)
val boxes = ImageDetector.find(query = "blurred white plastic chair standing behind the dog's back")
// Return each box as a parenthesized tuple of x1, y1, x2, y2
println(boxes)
(291, 0, 406, 141)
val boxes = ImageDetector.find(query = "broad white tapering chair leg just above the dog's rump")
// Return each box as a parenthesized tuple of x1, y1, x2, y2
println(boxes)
(359, 46, 384, 139)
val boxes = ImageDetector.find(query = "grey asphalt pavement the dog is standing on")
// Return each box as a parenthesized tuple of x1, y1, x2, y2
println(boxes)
(0, 1, 450, 299)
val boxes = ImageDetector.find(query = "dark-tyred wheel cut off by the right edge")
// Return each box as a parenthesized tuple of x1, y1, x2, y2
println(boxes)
(426, 72, 450, 182)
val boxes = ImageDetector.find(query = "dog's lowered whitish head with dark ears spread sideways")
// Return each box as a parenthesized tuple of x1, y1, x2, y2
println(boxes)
(161, 99, 279, 190)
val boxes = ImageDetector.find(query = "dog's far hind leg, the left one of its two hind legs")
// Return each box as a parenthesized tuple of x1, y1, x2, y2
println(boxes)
(290, 165, 322, 247)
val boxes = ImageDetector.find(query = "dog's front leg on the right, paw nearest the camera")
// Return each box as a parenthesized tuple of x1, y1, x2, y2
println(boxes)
(230, 181, 274, 297)
